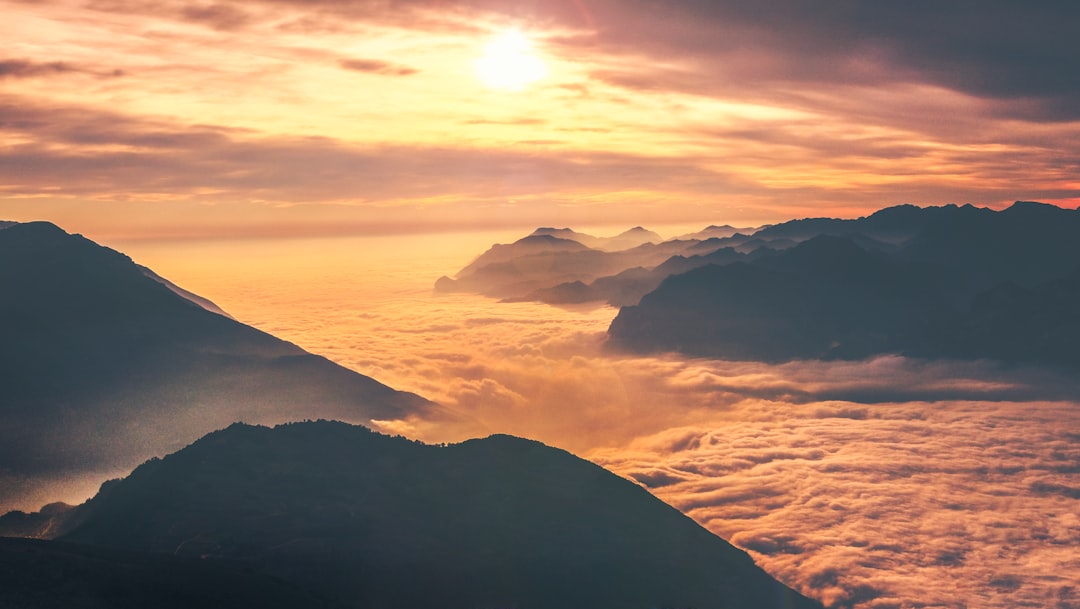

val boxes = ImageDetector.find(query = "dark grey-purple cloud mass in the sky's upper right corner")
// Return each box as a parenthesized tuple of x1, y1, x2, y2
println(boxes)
(583, 0, 1080, 121)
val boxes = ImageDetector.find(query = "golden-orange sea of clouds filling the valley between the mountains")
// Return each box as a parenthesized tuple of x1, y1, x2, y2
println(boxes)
(111, 231, 1080, 609)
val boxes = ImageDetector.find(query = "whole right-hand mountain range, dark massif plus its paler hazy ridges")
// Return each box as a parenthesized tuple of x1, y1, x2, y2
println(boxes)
(436, 201, 1080, 368)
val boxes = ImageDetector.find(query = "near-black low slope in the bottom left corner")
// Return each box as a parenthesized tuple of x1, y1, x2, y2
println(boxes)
(0, 539, 342, 609)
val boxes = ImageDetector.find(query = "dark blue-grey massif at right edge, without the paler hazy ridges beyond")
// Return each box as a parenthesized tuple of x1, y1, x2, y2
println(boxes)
(608, 202, 1080, 367)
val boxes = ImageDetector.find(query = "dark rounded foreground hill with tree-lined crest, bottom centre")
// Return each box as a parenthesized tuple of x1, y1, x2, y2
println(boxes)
(4, 421, 820, 609)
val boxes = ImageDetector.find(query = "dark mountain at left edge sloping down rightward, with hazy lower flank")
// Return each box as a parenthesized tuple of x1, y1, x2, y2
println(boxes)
(0, 222, 435, 511)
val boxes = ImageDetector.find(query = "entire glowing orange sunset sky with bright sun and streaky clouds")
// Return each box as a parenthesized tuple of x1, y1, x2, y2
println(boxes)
(0, 0, 1080, 239)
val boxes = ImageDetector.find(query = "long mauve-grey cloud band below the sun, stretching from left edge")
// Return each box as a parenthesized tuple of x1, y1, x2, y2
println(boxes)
(0, 92, 764, 210)
